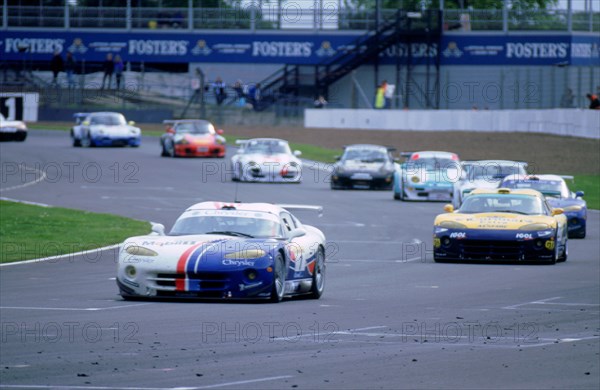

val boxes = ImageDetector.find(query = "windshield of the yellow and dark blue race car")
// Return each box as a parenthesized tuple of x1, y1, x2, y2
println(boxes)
(459, 194, 544, 215)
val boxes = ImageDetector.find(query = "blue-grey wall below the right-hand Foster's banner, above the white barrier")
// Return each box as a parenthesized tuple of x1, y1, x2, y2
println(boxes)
(328, 65, 600, 110)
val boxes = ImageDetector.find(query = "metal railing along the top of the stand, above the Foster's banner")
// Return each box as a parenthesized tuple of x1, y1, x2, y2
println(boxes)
(2, 3, 600, 32)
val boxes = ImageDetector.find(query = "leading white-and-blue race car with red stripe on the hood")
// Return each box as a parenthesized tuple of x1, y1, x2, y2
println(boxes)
(117, 202, 326, 302)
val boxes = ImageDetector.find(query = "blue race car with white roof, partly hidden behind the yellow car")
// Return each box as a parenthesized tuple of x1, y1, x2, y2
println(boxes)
(500, 175, 587, 238)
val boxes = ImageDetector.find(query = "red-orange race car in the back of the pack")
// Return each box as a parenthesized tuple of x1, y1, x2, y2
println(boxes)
(160, 119, 225, 158)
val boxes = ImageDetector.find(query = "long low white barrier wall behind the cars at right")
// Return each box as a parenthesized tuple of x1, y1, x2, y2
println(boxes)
(304, 109, 600, 139)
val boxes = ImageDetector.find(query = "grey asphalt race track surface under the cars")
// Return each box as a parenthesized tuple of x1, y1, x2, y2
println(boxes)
(0, 131, 600, 390)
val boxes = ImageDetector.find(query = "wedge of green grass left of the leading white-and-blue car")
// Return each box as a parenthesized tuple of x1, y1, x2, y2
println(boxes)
(0, 201, 150, 263)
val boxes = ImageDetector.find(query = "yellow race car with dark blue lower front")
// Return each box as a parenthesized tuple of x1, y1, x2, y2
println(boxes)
(433, 188, 568, 264)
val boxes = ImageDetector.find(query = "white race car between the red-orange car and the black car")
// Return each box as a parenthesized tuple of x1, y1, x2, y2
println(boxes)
(231, 138, 302, 183)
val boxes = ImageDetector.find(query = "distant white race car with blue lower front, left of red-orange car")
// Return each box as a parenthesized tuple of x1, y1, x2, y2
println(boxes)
(71, 112, 142, 147)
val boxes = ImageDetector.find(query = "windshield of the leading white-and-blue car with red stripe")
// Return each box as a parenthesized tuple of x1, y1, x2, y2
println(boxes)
(169, 215, 281, 238)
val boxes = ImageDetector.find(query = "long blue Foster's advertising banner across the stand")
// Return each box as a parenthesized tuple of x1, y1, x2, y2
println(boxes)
(0, 31, 600, 66)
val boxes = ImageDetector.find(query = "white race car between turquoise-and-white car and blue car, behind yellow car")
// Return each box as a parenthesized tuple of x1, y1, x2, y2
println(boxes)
(452, 160, 527, 209)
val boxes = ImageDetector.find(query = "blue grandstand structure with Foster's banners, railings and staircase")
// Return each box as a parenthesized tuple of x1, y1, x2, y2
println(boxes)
(0, 0, 600, 122)
